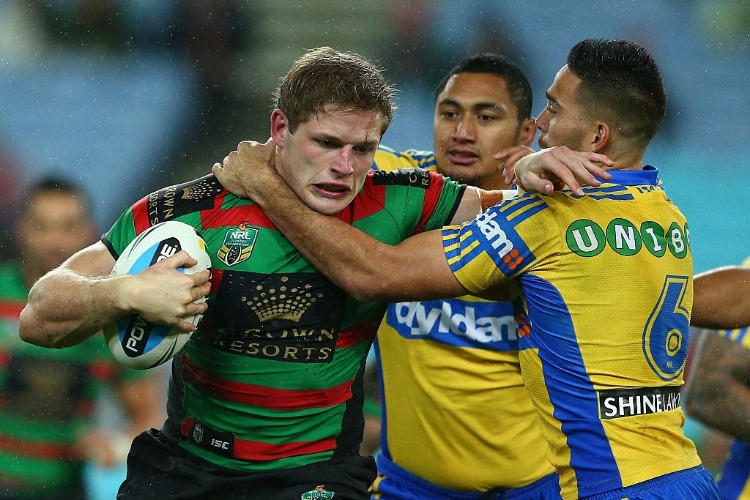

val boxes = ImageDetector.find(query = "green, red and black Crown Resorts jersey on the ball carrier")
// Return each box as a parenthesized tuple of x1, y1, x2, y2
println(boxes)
(104, 171, 463, 471)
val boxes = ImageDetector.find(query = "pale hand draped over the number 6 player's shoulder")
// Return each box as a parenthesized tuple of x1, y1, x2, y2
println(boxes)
(515, 146, 614, 196)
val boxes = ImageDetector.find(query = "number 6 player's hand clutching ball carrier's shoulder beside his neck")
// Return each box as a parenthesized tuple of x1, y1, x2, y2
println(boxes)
(211, 139, 276, 198)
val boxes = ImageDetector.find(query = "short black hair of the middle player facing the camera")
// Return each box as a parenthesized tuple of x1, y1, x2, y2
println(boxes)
(435, 53, 533, 123)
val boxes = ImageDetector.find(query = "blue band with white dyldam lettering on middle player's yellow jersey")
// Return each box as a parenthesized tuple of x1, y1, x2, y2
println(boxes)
(388, 299, 518, 350)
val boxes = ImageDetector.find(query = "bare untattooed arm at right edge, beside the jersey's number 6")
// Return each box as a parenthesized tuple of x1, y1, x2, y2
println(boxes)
(690, 266, 750, 329)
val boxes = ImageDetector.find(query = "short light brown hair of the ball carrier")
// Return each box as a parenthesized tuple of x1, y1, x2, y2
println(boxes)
(274, 47, 395, 133)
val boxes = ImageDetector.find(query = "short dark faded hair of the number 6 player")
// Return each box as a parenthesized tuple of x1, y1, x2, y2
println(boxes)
(567, 39, 667, 147)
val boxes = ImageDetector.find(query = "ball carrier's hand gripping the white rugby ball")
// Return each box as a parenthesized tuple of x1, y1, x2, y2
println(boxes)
(122, 250, 211, 332)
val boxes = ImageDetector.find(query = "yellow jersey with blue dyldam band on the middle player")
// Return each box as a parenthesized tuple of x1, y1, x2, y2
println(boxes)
(374, 147, 554, 491)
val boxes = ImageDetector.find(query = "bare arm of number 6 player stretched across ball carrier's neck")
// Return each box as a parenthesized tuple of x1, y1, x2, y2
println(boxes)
(213, 143, 468, 302)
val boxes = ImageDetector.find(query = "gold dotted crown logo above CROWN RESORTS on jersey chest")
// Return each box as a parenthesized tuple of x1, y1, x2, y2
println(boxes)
(242, 276, 323, 323)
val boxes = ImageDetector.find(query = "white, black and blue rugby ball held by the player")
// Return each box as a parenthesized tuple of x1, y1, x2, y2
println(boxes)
(103, 221, 211, 370)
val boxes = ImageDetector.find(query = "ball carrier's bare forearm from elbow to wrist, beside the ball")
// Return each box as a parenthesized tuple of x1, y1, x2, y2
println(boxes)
(19, 269, 127, 348)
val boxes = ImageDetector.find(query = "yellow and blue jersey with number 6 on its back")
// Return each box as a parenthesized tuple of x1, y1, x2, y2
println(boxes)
(443, 167, 700, 498)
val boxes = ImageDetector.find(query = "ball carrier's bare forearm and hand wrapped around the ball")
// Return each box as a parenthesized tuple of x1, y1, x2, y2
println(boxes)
(19, 242, 210, 347)
